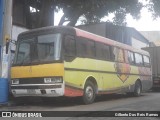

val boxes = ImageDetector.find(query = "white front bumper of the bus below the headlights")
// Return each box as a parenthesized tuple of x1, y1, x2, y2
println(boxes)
(11, 84, 64, 97)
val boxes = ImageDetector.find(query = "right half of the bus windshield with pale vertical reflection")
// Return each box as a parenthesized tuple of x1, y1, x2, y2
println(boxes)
(37, 34, 61, 62)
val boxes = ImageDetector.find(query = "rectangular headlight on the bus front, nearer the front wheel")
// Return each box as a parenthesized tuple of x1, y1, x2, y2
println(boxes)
(44, 77, 63, 83)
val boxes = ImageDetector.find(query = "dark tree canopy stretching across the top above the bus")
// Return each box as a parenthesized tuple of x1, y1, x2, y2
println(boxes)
(13, 0, 160, 28)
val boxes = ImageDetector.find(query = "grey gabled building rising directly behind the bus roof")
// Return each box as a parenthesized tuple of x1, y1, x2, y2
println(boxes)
(77, 23, 149, 49)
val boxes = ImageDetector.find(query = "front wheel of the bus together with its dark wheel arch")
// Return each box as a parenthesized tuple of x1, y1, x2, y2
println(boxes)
(82, 77, 98, 104)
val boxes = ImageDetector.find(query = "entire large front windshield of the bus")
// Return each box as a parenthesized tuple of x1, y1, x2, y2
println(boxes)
(13, 34, 61, 65)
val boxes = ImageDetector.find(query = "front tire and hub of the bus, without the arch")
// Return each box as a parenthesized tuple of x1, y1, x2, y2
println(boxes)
(83, 81, 96, 104)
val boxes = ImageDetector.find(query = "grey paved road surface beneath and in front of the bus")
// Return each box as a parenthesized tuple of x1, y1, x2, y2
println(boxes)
(0, 92, 160, 120)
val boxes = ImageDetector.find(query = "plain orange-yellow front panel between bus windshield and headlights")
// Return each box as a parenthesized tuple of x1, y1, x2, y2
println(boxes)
(11, 63, 64, 79)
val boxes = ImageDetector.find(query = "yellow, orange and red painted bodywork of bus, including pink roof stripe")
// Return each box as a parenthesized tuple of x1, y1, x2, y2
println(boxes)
(11, 26, 152, 104)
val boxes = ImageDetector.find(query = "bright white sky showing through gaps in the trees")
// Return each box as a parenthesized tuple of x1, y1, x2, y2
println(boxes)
(54, 0, 160, 31)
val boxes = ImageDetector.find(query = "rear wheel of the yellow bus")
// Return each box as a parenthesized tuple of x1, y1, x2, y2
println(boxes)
(133, 81, 142, 97)
